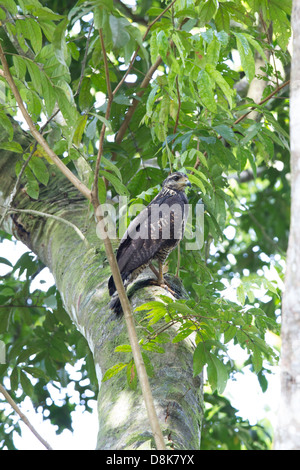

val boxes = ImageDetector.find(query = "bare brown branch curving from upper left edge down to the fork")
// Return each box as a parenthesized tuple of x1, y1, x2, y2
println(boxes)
(0, 44, 91, 200)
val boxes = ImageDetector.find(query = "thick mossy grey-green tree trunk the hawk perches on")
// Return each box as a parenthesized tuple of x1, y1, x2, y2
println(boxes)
(0, 131, 202, 450)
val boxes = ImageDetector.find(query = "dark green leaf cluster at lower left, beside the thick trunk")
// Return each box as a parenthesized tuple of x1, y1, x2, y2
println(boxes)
(0, 252, 96, 449)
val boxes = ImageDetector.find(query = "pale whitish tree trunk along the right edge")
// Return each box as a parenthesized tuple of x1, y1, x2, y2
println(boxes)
(275, 2, 300, 450)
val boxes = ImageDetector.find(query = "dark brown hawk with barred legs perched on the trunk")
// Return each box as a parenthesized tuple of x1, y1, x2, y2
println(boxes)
(108, 171, 191, 311)
